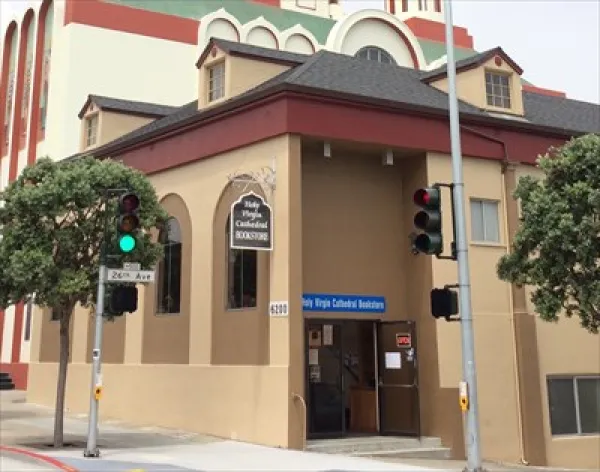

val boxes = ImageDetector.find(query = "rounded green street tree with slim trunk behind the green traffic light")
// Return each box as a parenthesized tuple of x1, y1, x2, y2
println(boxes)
(0, 157, 166, 447)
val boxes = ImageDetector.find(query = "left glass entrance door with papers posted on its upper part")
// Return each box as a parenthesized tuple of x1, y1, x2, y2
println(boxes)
(306, 321, 346, 438)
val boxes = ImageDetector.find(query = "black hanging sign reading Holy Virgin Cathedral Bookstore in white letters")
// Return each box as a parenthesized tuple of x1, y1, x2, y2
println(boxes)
(229, 192, 273, 251)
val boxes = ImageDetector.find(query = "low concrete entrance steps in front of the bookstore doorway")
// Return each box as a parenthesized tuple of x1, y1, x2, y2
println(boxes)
(306, 436, 450, 459)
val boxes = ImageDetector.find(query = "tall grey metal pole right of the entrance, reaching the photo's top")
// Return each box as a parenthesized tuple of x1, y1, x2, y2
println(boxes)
(444, 0, 483, 472)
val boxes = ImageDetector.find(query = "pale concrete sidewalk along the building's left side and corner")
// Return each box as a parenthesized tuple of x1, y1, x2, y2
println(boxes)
(0, 391, 439, 472)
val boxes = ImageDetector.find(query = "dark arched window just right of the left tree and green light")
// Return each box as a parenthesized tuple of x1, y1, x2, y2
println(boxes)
(156, 218, 181, 313)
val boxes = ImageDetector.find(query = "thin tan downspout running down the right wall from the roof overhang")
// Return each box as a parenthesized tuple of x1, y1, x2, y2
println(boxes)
(460, 125, 529, 465)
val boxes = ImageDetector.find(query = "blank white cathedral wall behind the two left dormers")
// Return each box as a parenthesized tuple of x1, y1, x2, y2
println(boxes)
(44, 24, 198, 159)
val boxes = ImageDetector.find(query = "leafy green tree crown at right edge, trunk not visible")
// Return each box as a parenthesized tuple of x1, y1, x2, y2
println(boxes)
(497, 134, 600, 334)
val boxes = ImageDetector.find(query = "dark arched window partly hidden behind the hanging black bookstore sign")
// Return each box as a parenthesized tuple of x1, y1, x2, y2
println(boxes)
(226, 218, 258, 310)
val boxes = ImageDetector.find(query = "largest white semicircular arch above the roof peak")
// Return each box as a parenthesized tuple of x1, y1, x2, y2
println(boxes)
(325, 10, 427, 69)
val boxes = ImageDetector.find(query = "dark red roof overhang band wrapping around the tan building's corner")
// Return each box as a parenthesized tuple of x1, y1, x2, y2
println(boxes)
(90, 85, 583, 174)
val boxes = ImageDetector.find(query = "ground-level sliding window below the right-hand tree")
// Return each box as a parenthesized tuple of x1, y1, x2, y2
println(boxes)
(547, 375, 600, 436)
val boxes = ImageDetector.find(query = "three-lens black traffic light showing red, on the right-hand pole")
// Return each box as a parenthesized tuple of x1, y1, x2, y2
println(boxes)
(413, 187, 444, 255)
